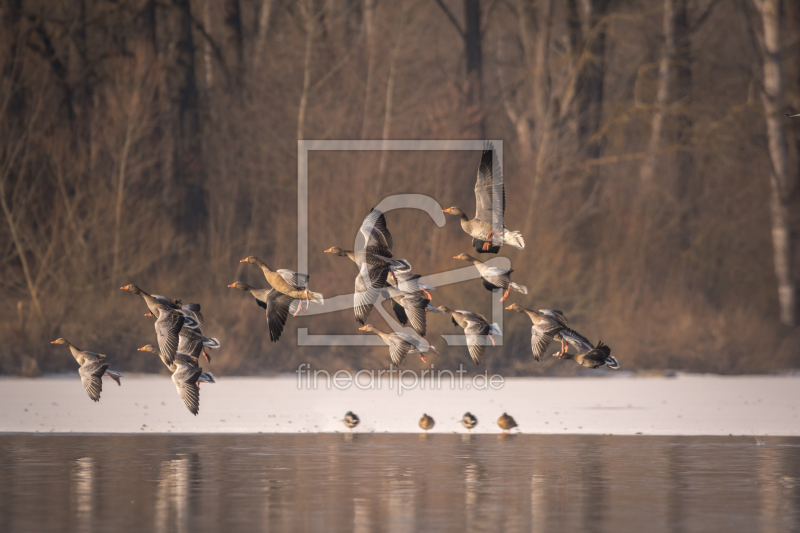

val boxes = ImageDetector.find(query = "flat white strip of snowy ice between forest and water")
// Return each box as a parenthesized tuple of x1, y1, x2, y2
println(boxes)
(0, 373, 800, 436)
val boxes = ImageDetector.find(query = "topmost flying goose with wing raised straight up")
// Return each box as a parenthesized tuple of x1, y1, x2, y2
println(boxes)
(442, 143, 525, 254)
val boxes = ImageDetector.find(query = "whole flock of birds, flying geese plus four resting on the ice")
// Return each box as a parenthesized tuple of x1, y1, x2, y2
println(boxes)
(52, 144, 619, 422)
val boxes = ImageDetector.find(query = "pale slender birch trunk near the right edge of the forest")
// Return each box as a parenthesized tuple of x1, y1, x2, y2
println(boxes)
(757, 0, 797, 326)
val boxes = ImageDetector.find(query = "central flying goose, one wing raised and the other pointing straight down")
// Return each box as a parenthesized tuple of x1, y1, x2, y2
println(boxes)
(325, 209, 411, 325)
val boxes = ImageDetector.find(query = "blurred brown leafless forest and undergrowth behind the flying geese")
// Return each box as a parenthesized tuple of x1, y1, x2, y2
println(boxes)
(0, 0, 800, 376)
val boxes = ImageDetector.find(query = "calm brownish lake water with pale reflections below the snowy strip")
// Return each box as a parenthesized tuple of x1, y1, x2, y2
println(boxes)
(0, 433, 800, 533)
